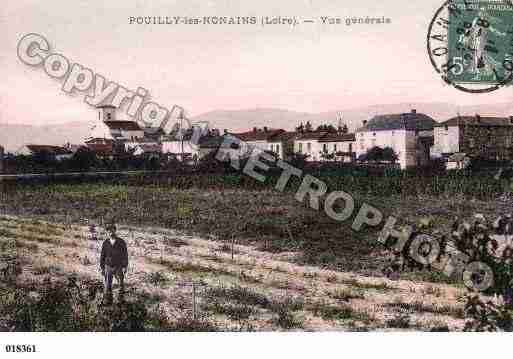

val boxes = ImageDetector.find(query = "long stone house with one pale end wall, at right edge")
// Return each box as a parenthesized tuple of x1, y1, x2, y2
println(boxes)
(431, 114, 513, 161)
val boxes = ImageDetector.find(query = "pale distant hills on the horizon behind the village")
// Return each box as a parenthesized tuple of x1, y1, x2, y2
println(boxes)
(0, 103, 513, 152)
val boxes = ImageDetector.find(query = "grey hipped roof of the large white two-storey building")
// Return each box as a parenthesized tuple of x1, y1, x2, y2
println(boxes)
(358, 112, 436, 131)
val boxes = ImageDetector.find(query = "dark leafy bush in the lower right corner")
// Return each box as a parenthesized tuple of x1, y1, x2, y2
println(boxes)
(384, 214, 513, 331)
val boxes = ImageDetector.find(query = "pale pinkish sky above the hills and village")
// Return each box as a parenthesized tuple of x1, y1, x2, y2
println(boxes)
(0, 0, 513, 125)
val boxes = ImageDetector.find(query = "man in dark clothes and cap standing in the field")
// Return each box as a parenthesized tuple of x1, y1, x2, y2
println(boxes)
(100, 223, 128, 305)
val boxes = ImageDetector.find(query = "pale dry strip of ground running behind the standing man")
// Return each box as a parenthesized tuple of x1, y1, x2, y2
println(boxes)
(0, 216, 464, 331)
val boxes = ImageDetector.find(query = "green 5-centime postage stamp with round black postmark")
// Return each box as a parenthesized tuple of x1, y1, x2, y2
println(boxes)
(427, 0, 513, 93)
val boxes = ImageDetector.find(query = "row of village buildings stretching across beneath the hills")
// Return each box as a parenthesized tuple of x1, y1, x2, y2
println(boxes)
(0, 106, 513, 172)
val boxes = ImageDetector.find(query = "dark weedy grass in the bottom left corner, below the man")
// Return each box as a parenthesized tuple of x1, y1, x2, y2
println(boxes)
(0, 281, 192, 332)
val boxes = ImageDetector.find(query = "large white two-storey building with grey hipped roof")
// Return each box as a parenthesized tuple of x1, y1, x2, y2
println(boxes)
(355, 110, 436, 169)
